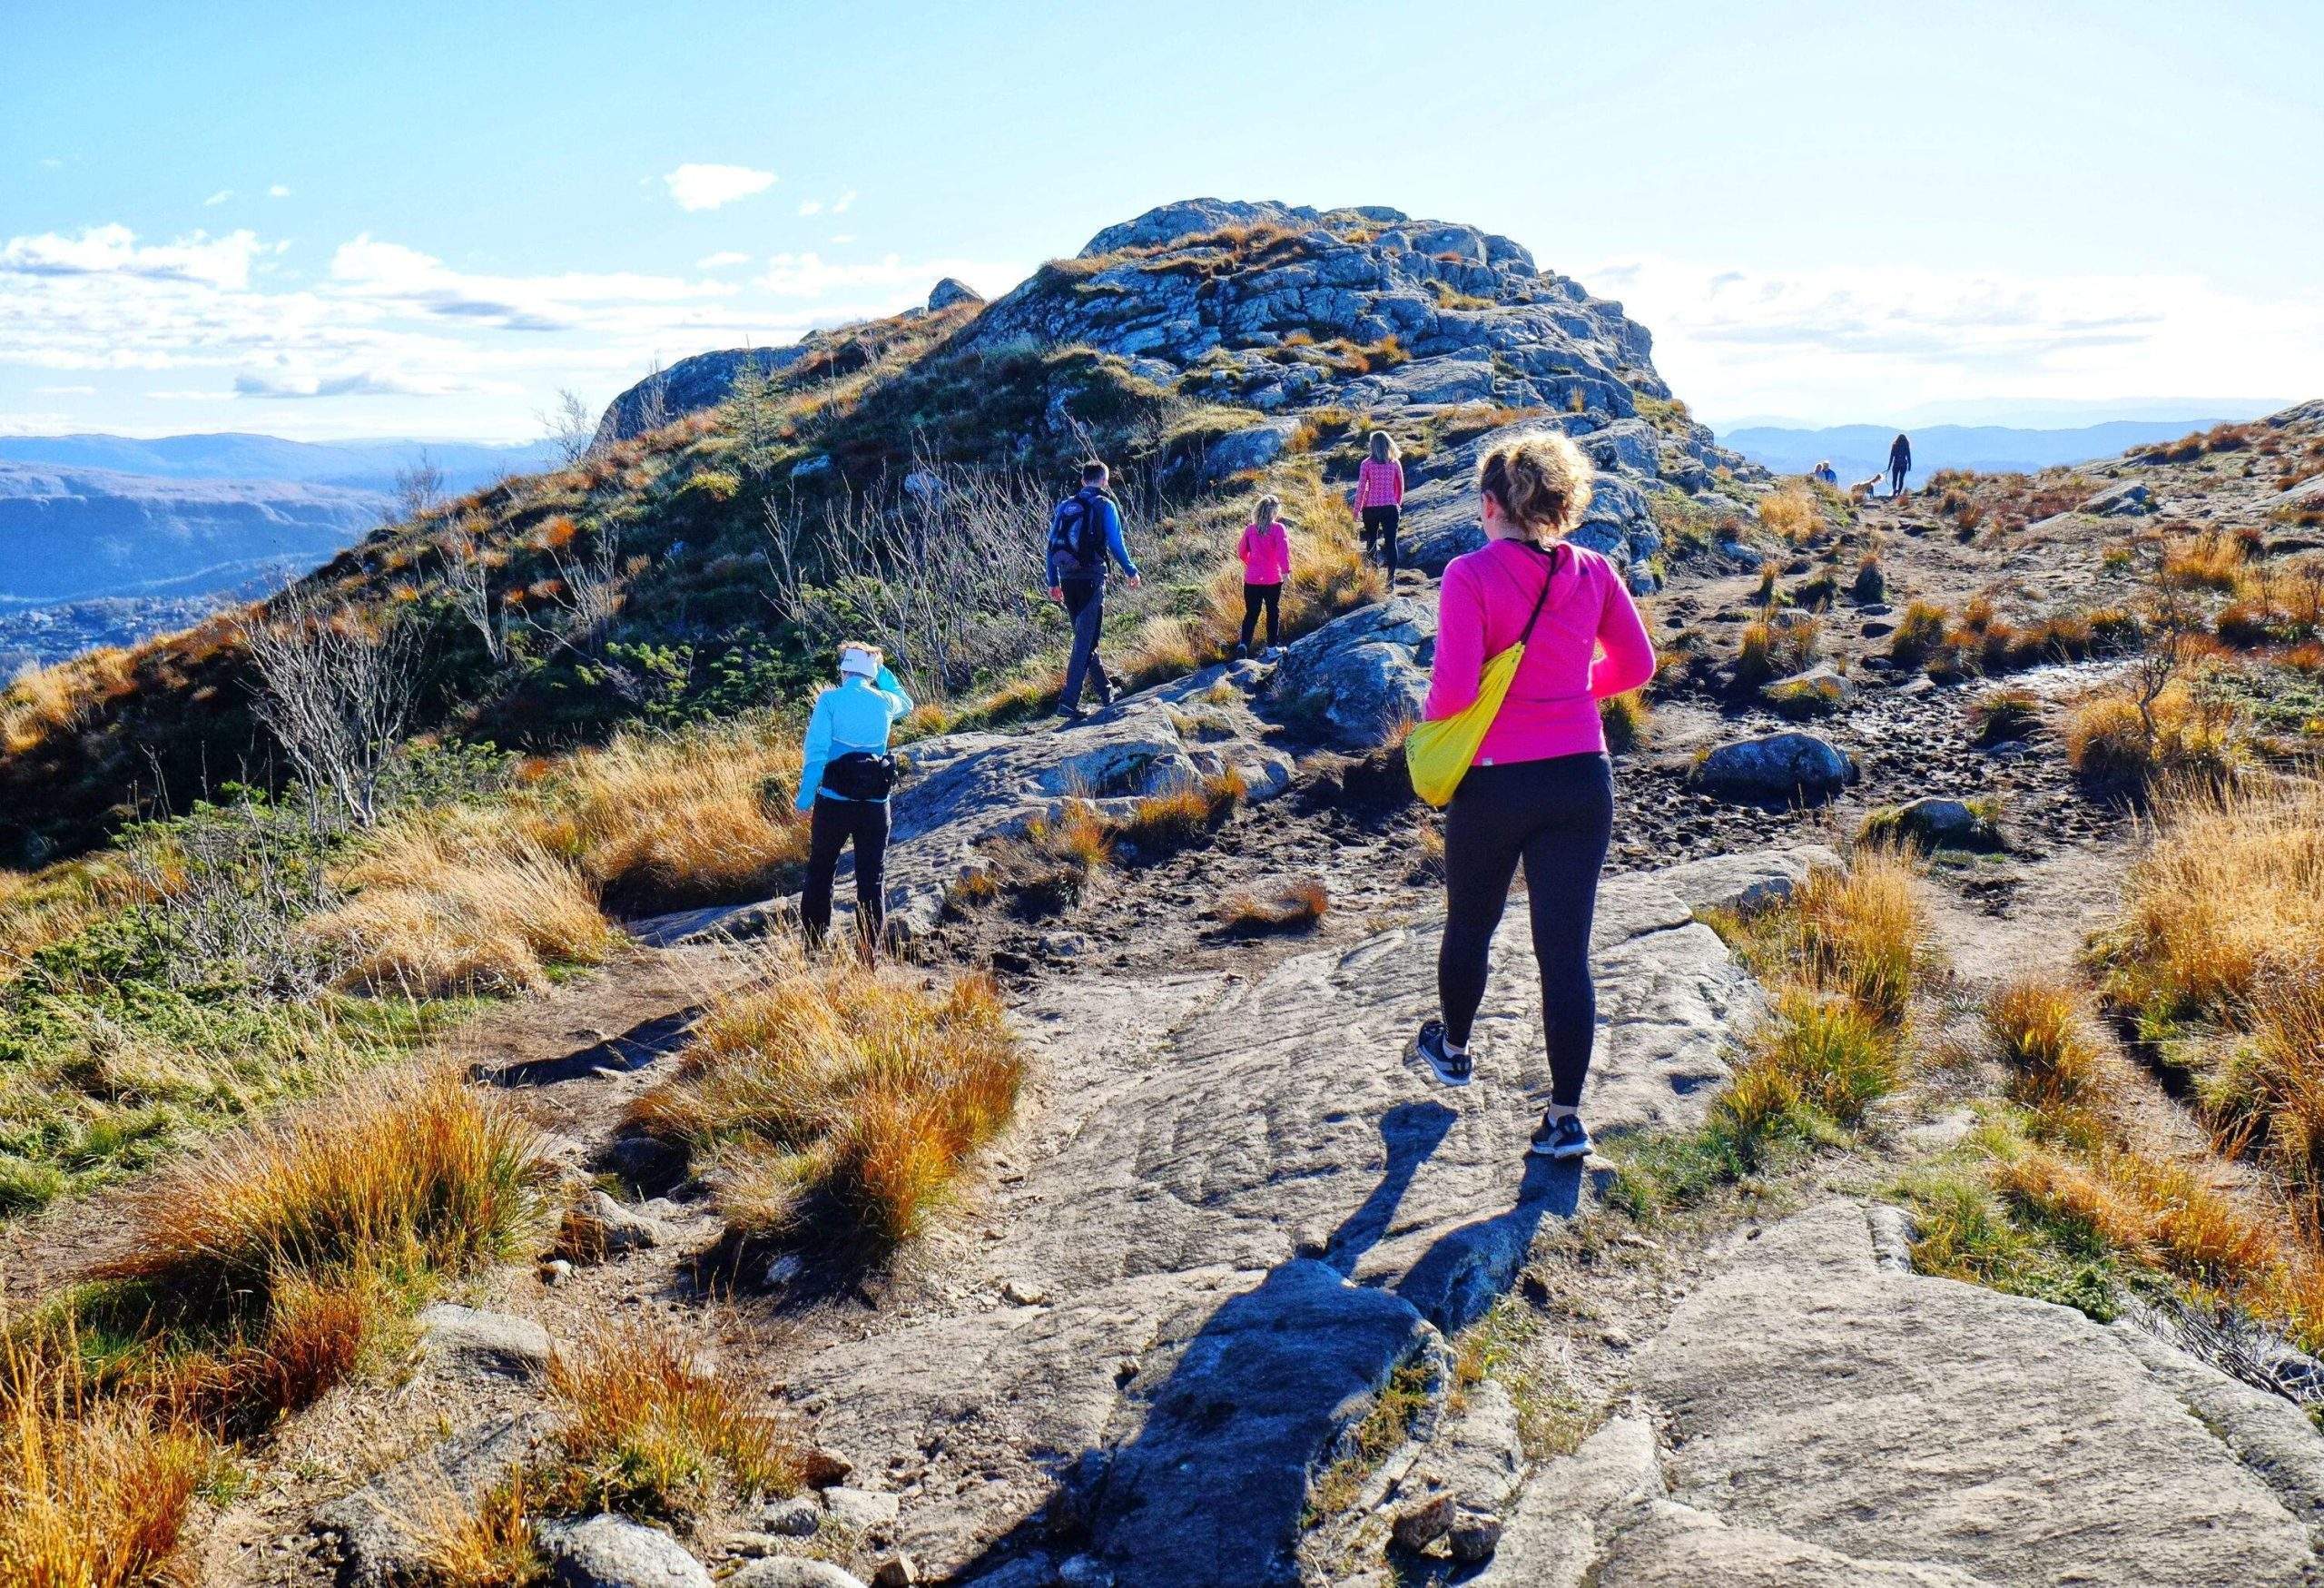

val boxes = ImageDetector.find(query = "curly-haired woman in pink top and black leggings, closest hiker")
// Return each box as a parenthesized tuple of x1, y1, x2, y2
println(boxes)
(1415, 435, 1655, 1158)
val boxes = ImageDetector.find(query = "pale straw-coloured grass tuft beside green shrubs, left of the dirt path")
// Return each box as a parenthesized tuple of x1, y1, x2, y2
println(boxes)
(302, 814, 621, 998)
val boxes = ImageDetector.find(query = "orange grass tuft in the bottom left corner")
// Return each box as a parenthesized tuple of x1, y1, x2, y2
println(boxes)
(0, 1326, 209, 1588)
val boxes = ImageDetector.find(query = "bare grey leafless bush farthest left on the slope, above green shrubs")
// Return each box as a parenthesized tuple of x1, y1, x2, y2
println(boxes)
(246, 586, 420, 828)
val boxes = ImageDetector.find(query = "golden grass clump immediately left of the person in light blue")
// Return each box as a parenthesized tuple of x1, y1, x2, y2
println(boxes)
(526, 728, 806, 912)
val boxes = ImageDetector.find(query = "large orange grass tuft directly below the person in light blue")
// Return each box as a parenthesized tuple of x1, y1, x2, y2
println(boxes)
(635, 946, 1022, 1244)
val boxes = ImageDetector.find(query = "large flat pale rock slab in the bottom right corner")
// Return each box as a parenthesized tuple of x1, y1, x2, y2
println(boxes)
(1473, 1199, 2324, 1588)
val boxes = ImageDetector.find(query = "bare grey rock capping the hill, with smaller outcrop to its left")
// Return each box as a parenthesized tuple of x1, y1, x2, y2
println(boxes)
(597, 198, 1767, 590)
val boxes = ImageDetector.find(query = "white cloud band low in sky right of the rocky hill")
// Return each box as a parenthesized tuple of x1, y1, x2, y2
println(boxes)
(1578, 258, 2324, 423)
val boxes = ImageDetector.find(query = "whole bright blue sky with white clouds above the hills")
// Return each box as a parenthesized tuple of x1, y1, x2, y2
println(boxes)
(0, 0, 2324, 439)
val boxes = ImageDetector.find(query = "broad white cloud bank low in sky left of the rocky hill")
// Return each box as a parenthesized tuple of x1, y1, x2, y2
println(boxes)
(0, 225, 1022, 437)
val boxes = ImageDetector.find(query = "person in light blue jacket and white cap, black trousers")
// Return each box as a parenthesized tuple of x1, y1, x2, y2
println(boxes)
(800, 642, 911, 955)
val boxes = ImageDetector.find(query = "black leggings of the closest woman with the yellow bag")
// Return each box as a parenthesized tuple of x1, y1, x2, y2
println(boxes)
(1436, 755, 1613, 1109)
